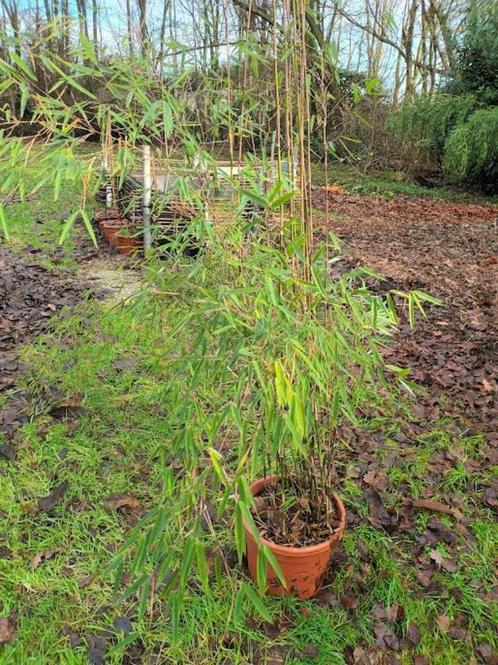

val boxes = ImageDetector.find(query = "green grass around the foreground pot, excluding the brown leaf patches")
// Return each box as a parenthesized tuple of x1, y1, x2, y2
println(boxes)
(0, 167, 498, 665)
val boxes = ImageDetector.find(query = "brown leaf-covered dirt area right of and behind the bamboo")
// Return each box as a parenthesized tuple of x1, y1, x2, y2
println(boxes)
(314, 189, 498, 446)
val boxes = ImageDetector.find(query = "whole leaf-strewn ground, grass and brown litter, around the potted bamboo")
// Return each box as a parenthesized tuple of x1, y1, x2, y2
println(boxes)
(0, 179, 498, 665)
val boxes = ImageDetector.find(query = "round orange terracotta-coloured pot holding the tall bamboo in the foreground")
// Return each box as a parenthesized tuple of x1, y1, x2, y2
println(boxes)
(244, 477, 346, 598)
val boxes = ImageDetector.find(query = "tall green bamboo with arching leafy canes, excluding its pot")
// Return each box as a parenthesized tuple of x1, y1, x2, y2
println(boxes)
(0, 9, 436, 629)
